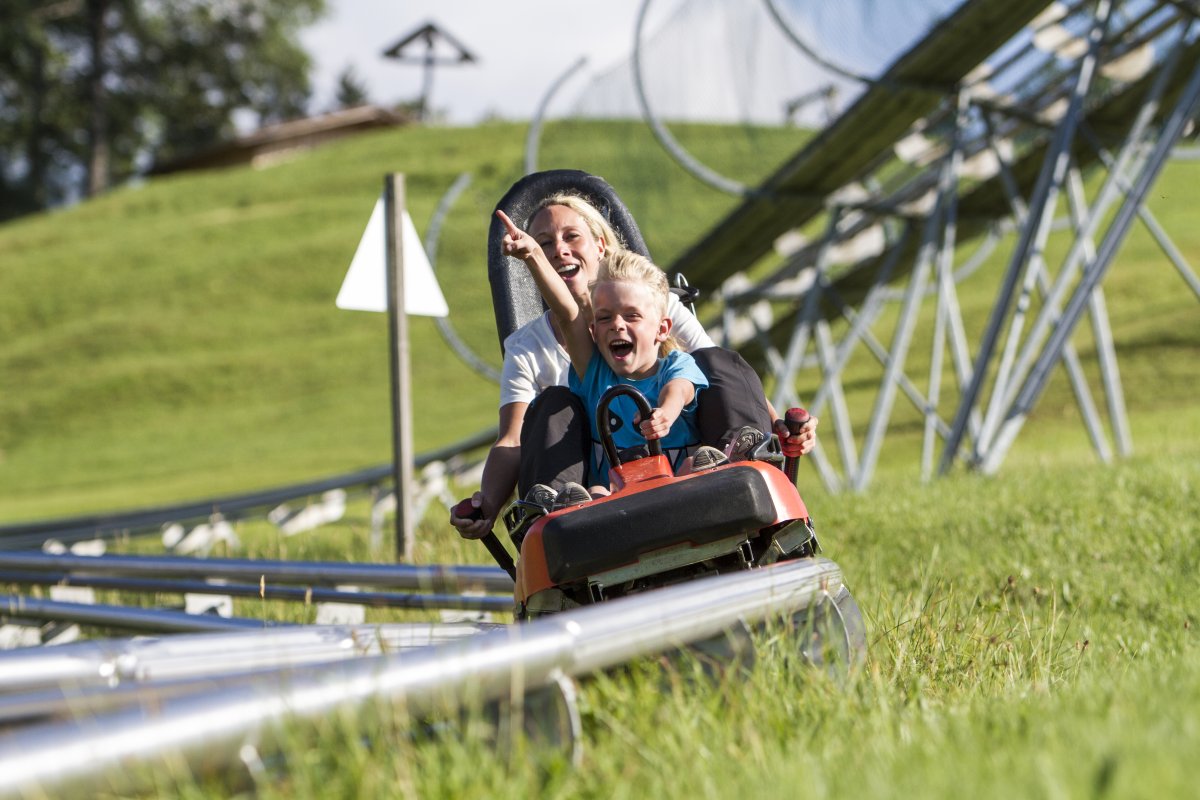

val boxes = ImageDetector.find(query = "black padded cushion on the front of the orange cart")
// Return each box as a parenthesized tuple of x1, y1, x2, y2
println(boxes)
(541, 465, 778, 584)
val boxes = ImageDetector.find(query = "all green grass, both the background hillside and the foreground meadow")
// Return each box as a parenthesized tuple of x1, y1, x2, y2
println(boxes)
(0, 117, 1200, 799)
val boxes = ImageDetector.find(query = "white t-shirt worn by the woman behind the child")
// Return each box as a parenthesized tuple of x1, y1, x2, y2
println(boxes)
(500, 293, 713, 408)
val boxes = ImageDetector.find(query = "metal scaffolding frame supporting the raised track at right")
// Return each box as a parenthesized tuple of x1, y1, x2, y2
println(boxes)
(696, 0, 1200, 491)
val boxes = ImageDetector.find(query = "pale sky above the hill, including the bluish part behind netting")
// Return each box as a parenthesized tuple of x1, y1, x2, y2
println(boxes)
(301, 0, 962, 125)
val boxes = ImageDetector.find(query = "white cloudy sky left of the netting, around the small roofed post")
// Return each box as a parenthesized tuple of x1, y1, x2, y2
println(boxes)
(301, 0, 657, 124)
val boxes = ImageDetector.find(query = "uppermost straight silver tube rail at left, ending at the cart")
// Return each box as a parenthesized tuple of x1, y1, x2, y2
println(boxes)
(0, 551, 512, 594)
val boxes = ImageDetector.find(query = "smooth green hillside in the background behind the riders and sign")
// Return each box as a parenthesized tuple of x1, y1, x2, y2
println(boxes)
(0, 117, 1200, 522)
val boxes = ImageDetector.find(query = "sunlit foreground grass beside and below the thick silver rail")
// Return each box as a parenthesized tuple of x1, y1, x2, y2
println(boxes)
(98, 448, 1200, 799)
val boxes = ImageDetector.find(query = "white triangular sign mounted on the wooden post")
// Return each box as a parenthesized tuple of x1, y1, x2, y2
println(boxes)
(337, 197, 450, 317)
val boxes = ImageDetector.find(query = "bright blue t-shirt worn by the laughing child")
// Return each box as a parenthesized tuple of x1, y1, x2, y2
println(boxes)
(568, 350, 708, 486)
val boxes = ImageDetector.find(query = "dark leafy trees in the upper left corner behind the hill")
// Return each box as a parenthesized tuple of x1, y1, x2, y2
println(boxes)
(0, 0, 325, 216)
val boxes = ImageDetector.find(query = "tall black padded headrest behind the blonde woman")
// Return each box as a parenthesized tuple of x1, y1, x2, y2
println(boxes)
(487, 169, 650, 348)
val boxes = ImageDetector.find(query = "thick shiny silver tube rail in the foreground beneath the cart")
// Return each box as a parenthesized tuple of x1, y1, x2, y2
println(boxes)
(0, 559, 842, 795)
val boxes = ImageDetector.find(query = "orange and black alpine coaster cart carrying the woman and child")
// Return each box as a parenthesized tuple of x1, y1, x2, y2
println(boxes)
(460, 170, 866, 666)
